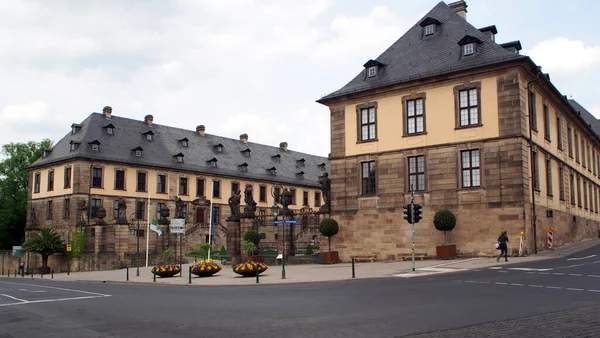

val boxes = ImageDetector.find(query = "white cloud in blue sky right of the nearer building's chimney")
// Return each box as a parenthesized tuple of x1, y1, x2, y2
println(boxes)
(527, 37, 600, 77)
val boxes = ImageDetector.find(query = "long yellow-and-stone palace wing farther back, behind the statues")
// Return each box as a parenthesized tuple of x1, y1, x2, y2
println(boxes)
(26, 107, 329, 269)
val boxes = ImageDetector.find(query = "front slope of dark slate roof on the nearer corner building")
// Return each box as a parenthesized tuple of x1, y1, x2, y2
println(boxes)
(318, 2, 524, 103)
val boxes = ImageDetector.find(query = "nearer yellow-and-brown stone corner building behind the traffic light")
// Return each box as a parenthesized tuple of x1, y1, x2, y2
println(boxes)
(317, 1, 600, 260)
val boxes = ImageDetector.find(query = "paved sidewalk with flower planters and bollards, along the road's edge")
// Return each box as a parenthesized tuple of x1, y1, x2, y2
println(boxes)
(2, 239, 600, 286)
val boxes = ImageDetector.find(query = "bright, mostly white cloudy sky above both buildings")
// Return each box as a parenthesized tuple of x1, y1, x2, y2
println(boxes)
(0, 0, 600, 156)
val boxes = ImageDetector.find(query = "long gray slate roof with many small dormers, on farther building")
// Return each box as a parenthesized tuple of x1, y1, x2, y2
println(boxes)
(30, 113, 330, 187)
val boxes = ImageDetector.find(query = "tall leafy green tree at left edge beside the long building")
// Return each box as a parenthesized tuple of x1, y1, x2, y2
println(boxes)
(0, 140, 52, 249)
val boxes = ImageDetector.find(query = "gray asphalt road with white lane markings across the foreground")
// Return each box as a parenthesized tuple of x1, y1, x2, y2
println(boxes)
(0, 246, 600, 338)
